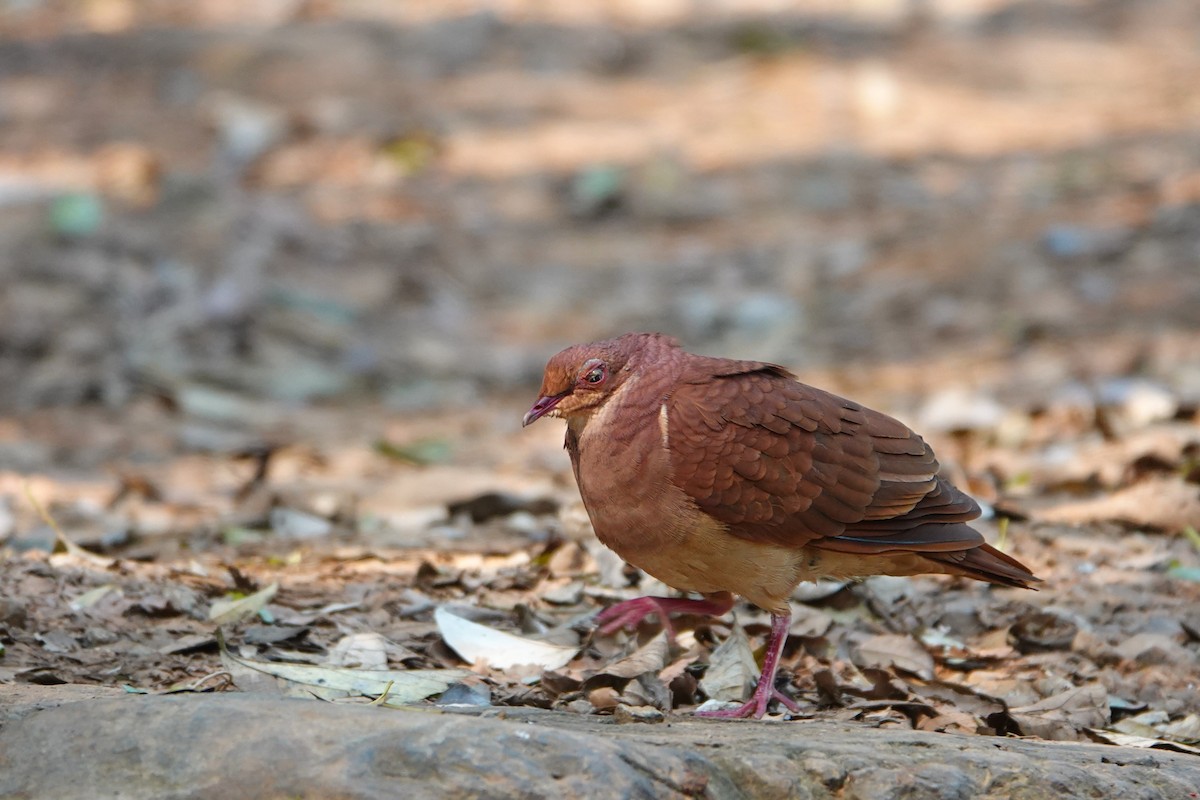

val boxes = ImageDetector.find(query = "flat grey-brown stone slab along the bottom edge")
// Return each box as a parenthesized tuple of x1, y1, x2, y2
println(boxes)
(0, 686, 1200, 800)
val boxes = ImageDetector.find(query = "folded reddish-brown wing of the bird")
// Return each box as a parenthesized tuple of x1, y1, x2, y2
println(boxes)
(667, 357, 983, 553)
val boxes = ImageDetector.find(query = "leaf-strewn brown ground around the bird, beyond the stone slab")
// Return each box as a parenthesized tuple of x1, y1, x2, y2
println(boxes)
(0, 0, 1200, 753)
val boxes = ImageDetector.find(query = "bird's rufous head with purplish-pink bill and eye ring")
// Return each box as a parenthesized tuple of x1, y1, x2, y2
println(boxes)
(522, 333, 679, 425)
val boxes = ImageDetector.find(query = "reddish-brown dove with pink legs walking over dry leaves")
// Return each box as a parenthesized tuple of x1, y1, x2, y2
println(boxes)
(522, 333, 1039, 718)
